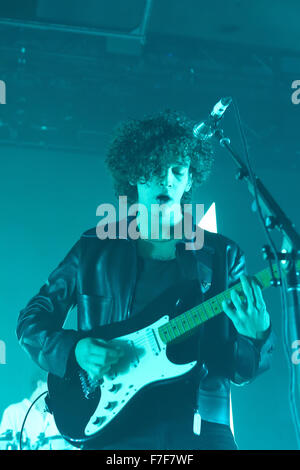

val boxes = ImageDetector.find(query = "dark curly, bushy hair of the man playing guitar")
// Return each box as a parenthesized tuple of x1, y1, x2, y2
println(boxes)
(105, 109, 213, 204)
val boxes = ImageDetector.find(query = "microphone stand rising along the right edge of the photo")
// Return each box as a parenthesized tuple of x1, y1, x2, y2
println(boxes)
(214, 123, 300, 448)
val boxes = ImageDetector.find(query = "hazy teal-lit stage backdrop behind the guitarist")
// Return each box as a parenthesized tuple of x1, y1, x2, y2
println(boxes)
(0, 0, 300, 449)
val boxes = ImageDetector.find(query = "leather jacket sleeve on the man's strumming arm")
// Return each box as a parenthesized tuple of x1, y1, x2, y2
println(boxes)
(17, 240, 81, 377)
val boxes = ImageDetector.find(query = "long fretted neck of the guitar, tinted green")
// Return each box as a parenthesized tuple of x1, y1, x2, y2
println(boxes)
(158, 260, 300, 344)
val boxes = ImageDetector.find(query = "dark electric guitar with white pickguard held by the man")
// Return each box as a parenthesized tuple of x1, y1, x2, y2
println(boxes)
(48, 261, 292, 447)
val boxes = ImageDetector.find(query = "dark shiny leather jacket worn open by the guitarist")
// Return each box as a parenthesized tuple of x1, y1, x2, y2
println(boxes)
(17, 218, 273, 424)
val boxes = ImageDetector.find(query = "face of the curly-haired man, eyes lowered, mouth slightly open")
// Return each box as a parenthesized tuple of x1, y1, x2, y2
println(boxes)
(137, 161, 192, 225)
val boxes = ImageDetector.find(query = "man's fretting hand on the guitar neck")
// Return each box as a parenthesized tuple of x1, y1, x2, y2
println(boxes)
(222, 274, 270, 339)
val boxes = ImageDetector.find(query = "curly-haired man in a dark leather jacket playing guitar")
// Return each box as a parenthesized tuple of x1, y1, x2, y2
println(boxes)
(17, 111, 273, 449)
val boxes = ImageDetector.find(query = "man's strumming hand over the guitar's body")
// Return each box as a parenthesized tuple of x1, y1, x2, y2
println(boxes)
(75, 338, 123, 380)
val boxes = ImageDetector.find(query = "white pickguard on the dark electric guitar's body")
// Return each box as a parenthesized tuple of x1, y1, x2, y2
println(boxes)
(84, 315, 197, 436)
